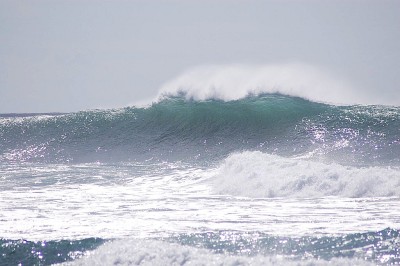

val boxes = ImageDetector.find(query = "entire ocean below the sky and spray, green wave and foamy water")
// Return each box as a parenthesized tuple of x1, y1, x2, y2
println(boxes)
(0, 93, 400, 265)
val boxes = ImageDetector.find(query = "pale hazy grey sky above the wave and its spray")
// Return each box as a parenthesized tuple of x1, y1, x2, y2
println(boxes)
(0, 0, 400, 113)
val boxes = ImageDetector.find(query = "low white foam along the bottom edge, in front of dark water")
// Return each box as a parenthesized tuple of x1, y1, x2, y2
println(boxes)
(64, 239, 371, 266)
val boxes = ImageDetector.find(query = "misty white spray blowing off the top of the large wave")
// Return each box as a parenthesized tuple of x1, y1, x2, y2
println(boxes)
(158, 63, 371, 104)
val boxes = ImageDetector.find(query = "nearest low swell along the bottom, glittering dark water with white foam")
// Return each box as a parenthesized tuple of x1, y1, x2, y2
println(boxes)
(5, 228, 394, 265)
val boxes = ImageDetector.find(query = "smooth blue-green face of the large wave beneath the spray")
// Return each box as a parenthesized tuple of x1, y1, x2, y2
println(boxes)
(0, 94, 400, 166)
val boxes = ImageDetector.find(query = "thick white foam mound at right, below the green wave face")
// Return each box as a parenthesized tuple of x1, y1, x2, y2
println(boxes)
(213, 151, 400, 198)
